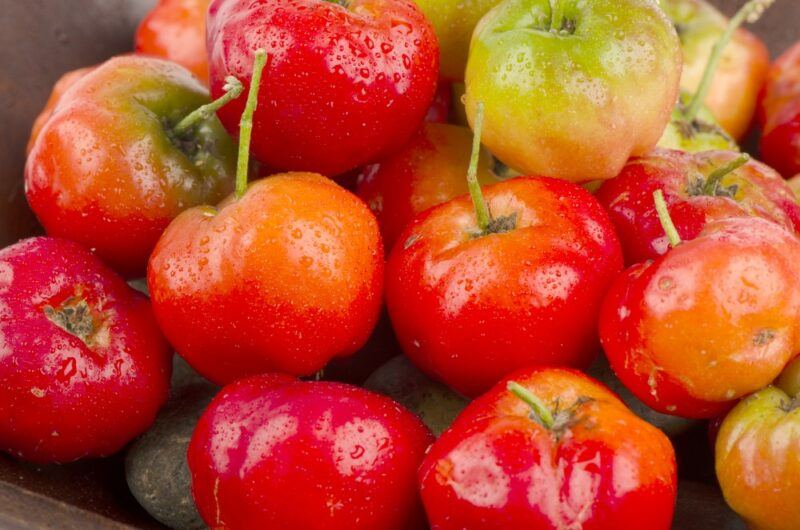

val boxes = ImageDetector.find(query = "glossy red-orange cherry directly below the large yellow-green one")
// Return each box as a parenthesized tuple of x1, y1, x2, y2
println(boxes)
(386, 177, 622, 396)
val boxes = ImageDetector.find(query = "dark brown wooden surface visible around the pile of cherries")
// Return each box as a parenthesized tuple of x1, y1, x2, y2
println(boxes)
(0, 0, 800, 530)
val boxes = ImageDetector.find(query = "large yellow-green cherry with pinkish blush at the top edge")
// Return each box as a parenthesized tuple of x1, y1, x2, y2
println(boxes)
(465, 0, 681, 182)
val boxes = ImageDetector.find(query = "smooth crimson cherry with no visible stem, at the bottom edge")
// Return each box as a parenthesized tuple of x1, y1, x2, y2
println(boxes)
(188, 374, 433, 530)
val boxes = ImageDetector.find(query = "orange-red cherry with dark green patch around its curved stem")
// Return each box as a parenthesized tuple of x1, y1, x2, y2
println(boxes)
(25, 56, 235, 277)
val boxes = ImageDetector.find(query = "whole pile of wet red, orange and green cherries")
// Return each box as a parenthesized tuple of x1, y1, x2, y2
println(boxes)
(0, 0, 800, 530)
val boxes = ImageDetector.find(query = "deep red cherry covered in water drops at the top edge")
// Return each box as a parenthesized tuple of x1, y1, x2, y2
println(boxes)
(208, 0, 439, 176)
